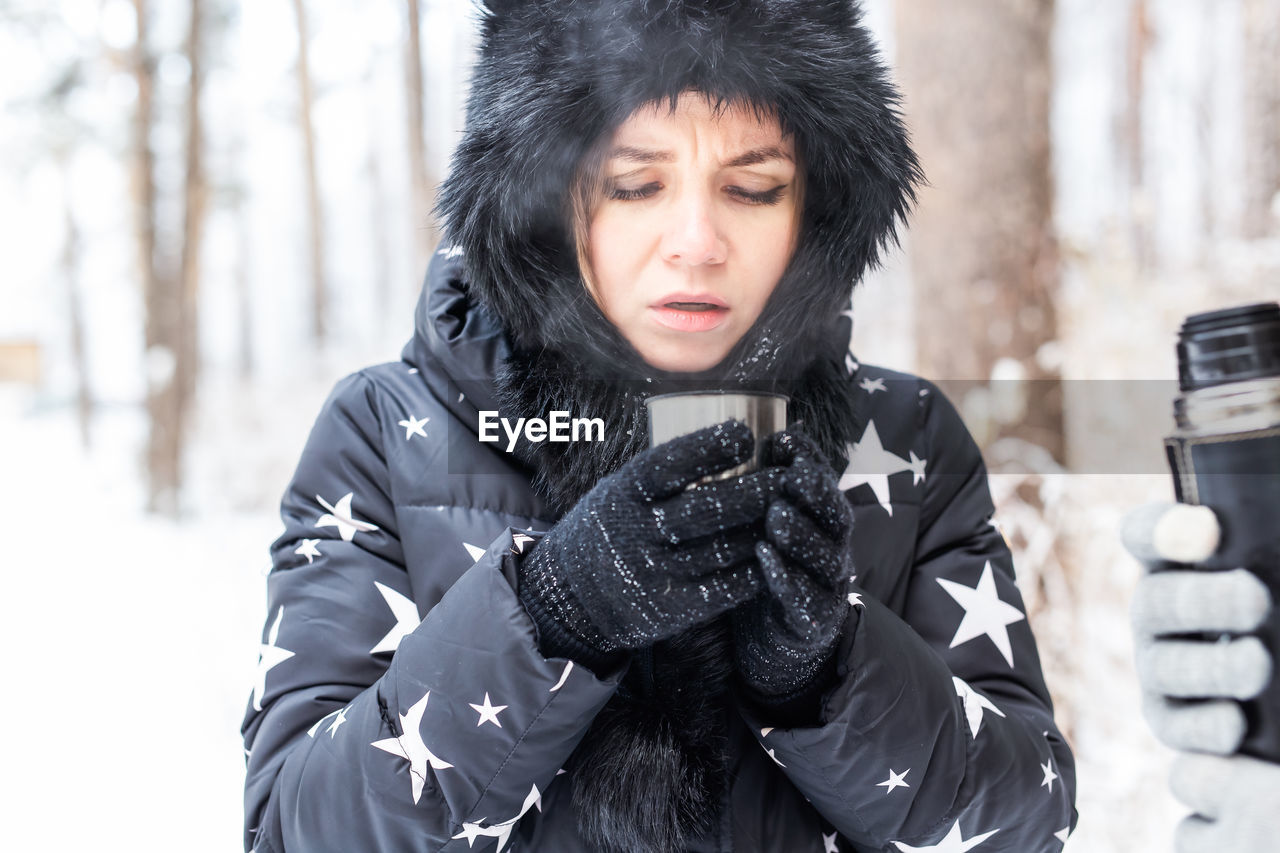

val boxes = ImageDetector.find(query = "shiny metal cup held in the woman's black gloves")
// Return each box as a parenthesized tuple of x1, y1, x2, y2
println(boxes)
(644, 391, 790, 485)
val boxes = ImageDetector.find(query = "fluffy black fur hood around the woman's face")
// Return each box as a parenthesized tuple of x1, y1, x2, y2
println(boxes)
(438, 0, 920, 383)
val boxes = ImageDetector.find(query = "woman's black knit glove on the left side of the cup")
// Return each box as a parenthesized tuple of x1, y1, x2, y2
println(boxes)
(517, 421, 782, 670)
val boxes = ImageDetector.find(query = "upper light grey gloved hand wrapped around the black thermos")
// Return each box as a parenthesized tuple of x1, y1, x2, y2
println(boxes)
(1121, 503, 1271, 747)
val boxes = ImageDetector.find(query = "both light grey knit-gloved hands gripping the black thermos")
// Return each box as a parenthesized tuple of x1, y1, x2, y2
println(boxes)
(1123, 503, 1280, 853)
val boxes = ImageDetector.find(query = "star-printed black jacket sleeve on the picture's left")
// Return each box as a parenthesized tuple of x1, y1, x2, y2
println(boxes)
(242, 374, 620, 853)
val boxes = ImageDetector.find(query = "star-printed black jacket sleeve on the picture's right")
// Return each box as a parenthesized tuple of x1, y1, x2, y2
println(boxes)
(744, 380, 1076, 853)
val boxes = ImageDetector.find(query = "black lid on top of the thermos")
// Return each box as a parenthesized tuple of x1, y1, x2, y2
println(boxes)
(1178, 302, 1280, 391)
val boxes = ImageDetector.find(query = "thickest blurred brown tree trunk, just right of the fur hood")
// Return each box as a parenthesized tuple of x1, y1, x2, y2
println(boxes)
(897, 0, 1064, 462)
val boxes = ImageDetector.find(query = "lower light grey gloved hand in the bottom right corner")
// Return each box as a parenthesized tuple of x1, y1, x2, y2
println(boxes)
(1170, 753, 1280, 853)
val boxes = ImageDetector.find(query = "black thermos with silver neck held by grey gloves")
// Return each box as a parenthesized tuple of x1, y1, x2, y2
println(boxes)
(1165, 302, 1280, 762)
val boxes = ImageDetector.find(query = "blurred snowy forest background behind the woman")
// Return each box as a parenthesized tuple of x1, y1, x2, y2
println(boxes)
(0, 0, 1280, 853)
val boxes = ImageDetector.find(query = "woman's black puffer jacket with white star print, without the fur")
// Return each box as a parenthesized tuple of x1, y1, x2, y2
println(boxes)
(243, 250, 1075, 853)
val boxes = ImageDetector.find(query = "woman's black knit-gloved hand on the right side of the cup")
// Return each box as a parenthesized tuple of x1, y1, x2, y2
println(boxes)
(732, 429, 854, 707)
